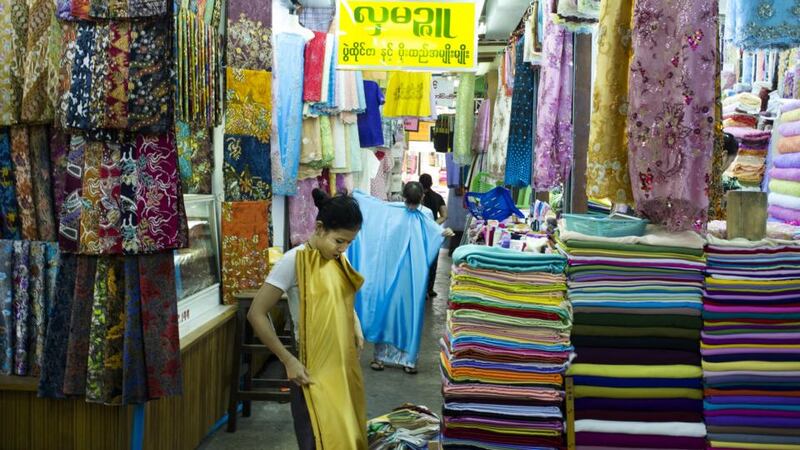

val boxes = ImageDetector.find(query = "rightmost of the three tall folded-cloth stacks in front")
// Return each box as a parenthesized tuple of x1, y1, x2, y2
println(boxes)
(702, 236, 800, 449)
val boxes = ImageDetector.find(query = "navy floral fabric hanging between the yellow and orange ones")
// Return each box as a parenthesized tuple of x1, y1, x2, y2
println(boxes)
(222, 135, 272, 201)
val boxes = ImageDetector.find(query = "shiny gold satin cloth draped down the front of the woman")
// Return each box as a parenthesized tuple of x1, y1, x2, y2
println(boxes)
(296, 246, 367, 450)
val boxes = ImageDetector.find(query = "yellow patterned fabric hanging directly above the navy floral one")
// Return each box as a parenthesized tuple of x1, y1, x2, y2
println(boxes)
(225, 67, 272, 142)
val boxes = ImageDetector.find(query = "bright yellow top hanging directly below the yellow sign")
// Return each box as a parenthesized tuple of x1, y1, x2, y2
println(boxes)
(383, 72, 431, 117)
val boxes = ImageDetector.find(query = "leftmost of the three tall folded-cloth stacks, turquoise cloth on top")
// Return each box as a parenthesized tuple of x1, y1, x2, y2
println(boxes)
(440, 245, 573, 449)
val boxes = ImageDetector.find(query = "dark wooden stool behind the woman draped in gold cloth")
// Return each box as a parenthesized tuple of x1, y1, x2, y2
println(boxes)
(228, 290, 297, 433)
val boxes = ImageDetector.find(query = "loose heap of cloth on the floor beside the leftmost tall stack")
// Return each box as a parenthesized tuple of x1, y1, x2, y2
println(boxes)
(367, 404, 440, 450)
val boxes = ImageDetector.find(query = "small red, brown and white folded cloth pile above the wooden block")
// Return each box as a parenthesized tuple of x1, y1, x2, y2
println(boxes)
(725, 127, 772, 190)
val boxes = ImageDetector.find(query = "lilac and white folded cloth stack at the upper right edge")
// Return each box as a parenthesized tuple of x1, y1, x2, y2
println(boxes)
(769, 101, 800, 225)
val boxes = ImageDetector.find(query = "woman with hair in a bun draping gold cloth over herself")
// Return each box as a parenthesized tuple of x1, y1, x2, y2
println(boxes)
(247, 189, 367, 450)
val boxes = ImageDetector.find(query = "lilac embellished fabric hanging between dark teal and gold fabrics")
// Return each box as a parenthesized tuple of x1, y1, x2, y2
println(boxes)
(533, 6, 573, 191)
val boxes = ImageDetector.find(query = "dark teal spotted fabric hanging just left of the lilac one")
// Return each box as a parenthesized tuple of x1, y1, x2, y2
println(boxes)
(506, 39, 538, 187)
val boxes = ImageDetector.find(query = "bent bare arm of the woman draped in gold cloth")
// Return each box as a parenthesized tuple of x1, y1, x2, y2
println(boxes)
(247, 283, 312, 386)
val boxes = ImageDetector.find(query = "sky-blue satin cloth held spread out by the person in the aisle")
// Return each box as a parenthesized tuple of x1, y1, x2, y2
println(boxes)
(347, 191, 444, 366)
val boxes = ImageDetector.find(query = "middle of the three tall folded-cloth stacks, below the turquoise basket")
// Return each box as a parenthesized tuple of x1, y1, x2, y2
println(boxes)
(559, 226, 705, 449)
